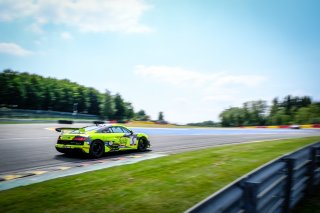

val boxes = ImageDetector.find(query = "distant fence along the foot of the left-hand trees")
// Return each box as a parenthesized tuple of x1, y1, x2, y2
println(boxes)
(0, 108, 99, 120)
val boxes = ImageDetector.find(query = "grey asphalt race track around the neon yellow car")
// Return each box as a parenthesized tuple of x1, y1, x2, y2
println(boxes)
(0, 124, 320, 175)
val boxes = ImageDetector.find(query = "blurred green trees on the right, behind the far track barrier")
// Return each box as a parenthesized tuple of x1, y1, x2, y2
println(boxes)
(219, 95, 320, 127)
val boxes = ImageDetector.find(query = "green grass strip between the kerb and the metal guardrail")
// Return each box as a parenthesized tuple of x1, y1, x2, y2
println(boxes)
(0, 137, 320, 212)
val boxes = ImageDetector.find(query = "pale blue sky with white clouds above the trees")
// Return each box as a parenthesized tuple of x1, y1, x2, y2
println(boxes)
(0, 0, 320, 124)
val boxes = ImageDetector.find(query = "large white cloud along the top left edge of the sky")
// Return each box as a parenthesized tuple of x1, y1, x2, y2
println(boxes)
(0, 0, 151, 33)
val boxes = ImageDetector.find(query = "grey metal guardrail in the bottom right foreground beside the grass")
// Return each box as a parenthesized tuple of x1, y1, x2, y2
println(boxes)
(186, 142, 320, 213)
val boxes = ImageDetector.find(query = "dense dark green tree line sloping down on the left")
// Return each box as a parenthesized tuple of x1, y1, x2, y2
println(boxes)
(0, 69, 150, 120)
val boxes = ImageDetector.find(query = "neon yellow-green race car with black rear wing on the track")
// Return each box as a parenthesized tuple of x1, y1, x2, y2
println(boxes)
(55, 124, 150, 158)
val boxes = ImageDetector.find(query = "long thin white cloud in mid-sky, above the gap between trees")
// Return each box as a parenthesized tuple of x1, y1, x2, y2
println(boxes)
(134, 65, 265, 89)
